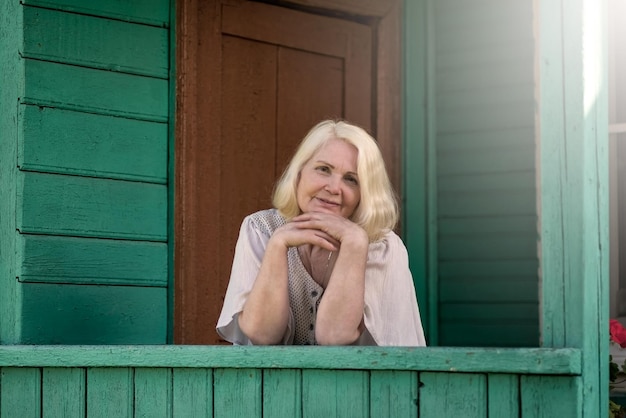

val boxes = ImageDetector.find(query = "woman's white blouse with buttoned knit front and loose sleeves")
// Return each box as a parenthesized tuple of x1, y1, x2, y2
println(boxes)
(217, 209, 426, 346)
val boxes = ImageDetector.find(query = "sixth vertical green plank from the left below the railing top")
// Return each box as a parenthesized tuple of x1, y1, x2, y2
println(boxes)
(213, 369, 263, 418)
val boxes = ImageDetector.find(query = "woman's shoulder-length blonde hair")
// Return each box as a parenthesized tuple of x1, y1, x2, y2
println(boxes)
(272, 120, 398, 242)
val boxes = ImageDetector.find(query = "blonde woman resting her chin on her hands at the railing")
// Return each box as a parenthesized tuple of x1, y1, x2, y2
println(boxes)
(217, 121, 426, 346)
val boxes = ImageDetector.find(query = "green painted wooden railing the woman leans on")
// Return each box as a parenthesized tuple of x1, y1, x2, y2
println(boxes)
(0, 346, 582, 418)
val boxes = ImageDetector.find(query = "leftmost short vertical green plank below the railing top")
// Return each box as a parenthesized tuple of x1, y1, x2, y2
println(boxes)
(0, 367, 41, 418)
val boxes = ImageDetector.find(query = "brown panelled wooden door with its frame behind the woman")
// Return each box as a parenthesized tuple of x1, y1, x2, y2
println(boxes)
(174, 0, 400, 344)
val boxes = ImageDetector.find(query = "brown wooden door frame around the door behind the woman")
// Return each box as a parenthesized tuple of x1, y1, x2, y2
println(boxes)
(172, 0, 402, 344)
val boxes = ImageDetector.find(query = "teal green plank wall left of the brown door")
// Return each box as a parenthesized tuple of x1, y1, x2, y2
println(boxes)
(0, 0, 170, 344)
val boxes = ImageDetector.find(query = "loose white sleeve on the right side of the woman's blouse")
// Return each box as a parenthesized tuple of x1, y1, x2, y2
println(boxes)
(364, 232, 426, 346)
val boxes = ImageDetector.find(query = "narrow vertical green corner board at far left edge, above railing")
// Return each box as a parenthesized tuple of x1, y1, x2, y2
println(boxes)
(0, 1, 24, 344)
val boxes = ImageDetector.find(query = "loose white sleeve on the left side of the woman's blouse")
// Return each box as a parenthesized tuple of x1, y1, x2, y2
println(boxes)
(216, 216, 294, 345)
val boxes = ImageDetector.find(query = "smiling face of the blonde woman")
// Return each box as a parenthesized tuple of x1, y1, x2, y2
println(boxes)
(296, 139, 361, 218)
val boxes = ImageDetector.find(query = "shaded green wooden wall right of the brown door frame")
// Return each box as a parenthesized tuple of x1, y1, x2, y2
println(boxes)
(405, 0, 539, 346)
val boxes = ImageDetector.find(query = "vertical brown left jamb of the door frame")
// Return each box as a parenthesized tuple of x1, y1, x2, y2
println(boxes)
(170, 0, 227, 344)
